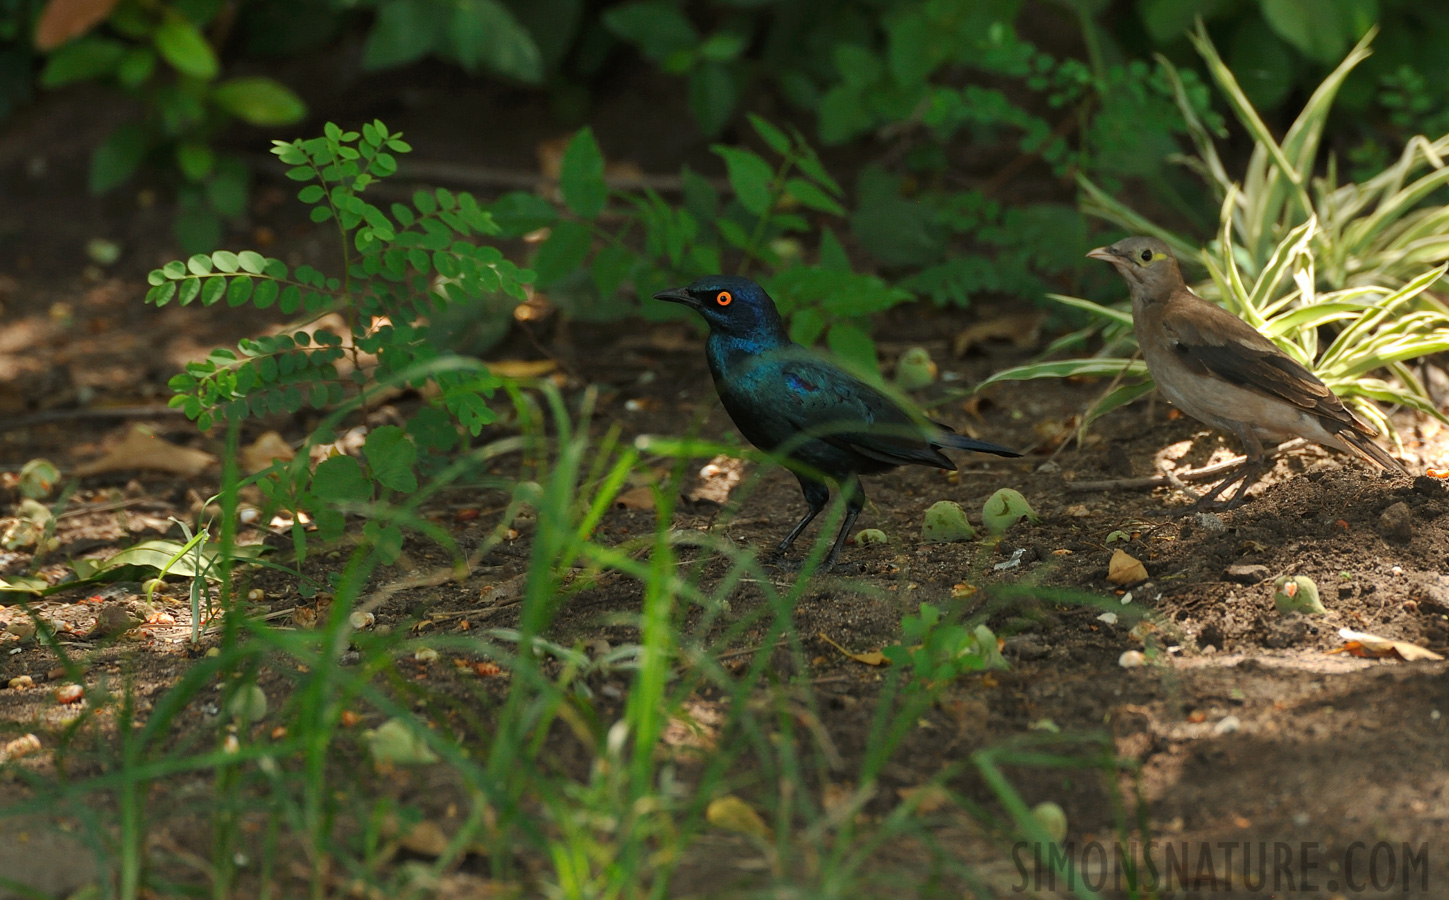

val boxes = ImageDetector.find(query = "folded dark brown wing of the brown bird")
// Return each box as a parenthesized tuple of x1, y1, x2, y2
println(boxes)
(1162, 290, 1374, 435)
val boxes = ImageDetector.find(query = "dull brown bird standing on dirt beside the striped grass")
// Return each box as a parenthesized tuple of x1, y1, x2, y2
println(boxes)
(1087, 238, 1408, 509)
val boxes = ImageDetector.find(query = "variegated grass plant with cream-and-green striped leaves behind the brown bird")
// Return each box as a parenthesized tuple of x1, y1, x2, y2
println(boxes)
(982, 25, 1449, 443)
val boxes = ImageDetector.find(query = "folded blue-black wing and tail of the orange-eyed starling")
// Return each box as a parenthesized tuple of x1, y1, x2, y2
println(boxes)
(780, 359, 1016, 468)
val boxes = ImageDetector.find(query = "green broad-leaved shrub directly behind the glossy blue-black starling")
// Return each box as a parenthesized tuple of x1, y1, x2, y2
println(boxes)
(490, 116, 911, 368)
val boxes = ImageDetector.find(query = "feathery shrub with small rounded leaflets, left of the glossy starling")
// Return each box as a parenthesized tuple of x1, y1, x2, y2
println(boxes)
(146, 122, 532, 565)
